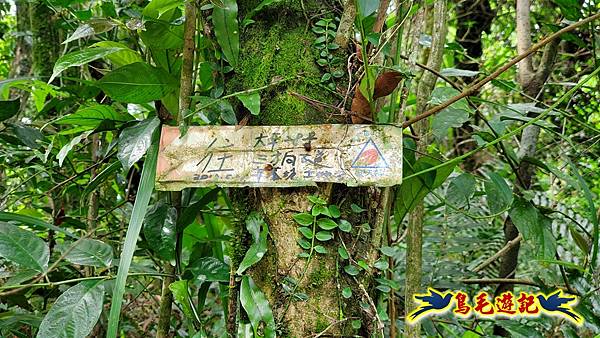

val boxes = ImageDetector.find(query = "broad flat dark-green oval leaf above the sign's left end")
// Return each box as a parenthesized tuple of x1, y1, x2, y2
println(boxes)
(98, 62, 174, 103)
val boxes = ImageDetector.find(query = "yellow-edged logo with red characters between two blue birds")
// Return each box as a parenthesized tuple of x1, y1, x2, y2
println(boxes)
(407, 288, 583, 325)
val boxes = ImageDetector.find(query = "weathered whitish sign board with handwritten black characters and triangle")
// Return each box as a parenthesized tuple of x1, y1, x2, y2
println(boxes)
(156, 124, 402, 190)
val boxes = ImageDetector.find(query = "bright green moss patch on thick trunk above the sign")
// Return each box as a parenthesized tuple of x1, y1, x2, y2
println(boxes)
(227, 1, 338, 125)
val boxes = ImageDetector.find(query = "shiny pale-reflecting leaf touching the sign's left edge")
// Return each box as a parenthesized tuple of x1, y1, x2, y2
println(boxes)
(117, 117, 160, 170)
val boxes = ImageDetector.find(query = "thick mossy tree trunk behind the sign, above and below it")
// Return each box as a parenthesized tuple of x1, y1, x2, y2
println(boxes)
(226, 0, 382, 337)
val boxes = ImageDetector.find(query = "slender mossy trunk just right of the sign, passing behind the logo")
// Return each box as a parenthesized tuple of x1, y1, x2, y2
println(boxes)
(405, 0, 447, 338)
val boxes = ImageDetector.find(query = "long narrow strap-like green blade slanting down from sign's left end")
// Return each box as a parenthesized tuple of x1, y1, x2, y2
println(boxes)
(107, 133, 159, 337)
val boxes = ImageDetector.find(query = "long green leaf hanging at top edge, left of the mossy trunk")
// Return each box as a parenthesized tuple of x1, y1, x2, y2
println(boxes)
(212, 0, 240, 68)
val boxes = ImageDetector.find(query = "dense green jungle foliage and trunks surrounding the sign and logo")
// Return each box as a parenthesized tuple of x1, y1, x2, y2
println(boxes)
(0, 0, 600, 338)
